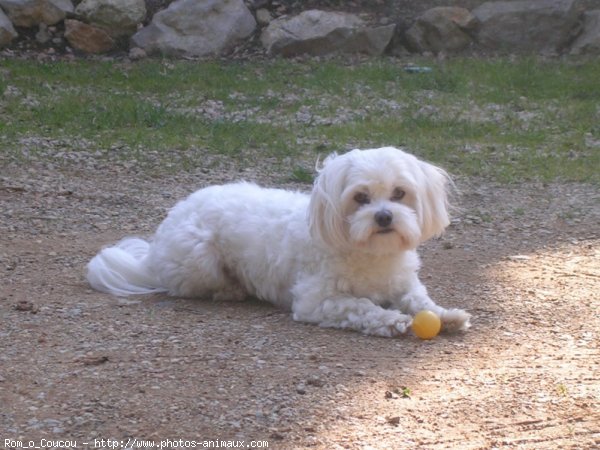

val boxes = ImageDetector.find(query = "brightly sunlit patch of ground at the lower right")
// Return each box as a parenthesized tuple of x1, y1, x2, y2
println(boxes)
(309, 239, 600, 449)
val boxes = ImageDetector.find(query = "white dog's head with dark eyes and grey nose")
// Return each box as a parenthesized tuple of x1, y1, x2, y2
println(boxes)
(309, 147, 449, 254)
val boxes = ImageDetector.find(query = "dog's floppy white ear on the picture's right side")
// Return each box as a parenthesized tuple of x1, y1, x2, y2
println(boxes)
(416, 161, 450, 242)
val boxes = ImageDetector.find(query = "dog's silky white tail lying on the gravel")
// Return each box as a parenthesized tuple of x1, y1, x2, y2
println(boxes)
(87, 238, 167, 296)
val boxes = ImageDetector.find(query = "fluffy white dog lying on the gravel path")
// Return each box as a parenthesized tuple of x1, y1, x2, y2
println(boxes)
(88, 147, 470, 336)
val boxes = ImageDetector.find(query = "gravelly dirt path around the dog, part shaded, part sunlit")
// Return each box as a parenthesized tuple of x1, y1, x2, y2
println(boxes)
(0, 156, 600, 449)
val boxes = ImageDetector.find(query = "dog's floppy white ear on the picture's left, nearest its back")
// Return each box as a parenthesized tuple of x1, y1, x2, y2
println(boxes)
(308, 153, 350, 249)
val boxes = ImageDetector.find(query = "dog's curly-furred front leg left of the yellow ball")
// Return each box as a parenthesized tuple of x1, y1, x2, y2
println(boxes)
(292, 292, 412, 337)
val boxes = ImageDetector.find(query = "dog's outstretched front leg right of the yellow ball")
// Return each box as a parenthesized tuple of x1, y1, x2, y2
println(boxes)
(392, 276, 471, 331)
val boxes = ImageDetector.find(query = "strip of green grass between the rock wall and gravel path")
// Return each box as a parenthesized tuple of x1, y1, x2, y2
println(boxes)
(0, 58, 600, 183)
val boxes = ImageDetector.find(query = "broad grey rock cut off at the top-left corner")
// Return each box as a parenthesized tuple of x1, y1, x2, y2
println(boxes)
(0, 0, 73, 27)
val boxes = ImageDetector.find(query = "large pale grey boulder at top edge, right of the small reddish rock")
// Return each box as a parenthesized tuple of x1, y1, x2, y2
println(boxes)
(131, 0, 256, 56)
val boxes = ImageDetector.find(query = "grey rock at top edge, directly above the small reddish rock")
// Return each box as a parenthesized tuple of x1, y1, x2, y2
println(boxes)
(75, 0, 146, 37)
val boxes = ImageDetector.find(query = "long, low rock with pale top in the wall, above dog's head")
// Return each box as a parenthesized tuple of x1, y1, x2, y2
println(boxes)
(260, 9, 395, 56)
